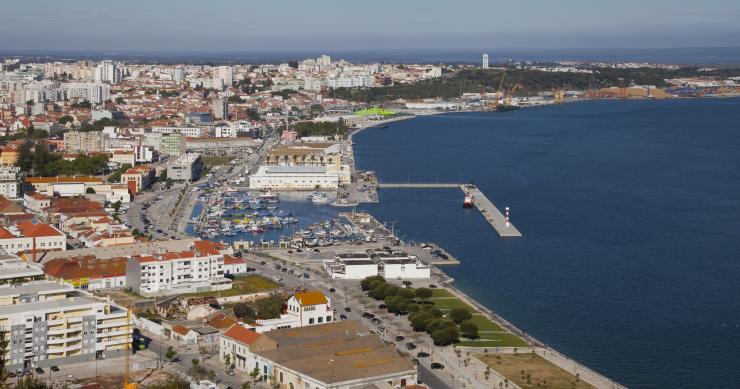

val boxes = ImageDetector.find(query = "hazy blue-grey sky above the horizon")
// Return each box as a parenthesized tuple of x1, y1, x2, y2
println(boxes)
(0, 0, 740, 52)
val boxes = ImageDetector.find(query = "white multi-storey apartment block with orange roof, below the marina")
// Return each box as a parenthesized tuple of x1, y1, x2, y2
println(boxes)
(126, 247, 231, 297)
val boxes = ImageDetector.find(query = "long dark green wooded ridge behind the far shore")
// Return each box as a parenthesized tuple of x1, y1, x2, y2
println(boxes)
(333, 67, 738, 103)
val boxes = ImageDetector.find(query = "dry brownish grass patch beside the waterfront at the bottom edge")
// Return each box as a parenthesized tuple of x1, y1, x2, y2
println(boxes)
(476, 354, 593, 389)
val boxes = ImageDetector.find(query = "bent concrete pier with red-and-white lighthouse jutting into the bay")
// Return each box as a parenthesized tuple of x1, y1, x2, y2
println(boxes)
(378, 182, 522, 238)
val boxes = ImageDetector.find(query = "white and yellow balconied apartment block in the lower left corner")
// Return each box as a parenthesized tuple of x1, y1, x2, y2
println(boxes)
(0, 266, 132, 371)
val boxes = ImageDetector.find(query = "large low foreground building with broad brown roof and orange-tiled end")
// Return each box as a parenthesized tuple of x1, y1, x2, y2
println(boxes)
(219, 320, 416, 389)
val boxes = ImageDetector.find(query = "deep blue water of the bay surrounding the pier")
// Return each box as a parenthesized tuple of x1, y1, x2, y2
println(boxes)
(354, 100, 740, 388)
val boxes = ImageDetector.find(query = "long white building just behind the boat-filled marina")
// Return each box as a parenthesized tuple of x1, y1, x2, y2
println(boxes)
(249, 166, 339, 190)
